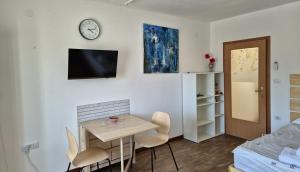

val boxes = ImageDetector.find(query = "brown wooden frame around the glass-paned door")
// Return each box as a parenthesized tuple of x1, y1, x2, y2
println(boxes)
(223, 36, 271, 134)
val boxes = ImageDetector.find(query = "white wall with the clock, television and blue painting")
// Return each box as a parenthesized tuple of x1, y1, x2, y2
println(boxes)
(0, 0, 210, 172)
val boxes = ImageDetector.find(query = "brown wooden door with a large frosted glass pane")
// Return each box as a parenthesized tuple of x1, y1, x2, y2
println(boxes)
(223, 37, 270, 140)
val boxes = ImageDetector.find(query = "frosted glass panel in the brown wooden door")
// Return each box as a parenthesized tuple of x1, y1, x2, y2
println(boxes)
(231, 47, 260, 122)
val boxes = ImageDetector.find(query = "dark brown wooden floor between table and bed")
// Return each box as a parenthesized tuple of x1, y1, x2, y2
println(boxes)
(100, 135, 245, 172)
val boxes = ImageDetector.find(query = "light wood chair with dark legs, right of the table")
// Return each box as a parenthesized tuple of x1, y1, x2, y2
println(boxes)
(134, 112, 178, 172)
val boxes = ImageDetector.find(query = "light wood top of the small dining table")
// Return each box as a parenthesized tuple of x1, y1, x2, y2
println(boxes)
(81, 115, 158, 142)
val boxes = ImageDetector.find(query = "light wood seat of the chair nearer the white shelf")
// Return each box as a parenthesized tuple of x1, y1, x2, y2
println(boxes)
(134, 135, 168, 148)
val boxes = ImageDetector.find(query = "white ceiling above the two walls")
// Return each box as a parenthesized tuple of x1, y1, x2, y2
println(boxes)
(99, 0, 299, 21)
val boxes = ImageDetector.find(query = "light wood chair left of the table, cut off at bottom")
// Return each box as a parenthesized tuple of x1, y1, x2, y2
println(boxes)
(66, 128, 112, 172)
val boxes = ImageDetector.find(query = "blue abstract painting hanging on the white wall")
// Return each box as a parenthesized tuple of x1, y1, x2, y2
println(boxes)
(143, 24, 179, 73)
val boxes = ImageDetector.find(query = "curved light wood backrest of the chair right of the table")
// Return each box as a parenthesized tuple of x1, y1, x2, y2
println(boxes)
(152, 112, 171, 137)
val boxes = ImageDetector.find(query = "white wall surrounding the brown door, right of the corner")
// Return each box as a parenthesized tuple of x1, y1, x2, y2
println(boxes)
(211, 2, 300, 131)
